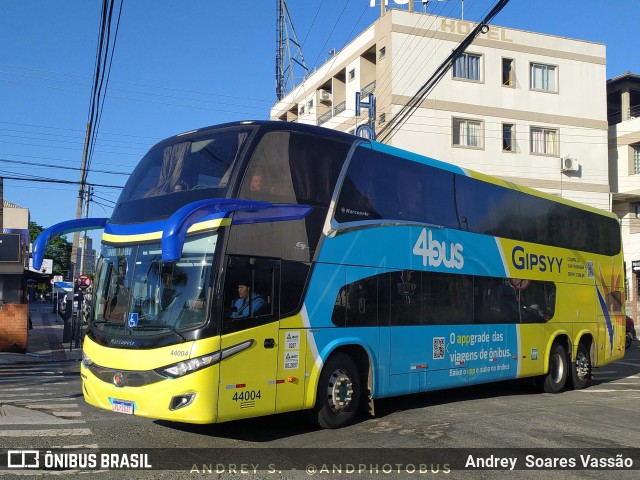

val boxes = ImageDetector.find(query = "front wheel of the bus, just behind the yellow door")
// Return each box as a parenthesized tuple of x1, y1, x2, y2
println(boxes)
(312, 353, 361, 428)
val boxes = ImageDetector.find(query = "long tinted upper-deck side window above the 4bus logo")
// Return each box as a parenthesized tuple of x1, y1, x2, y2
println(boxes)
(335, 147, 620, 255)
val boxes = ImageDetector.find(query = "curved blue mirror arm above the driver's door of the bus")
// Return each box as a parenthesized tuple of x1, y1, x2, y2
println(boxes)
(162, 198, 311, 262)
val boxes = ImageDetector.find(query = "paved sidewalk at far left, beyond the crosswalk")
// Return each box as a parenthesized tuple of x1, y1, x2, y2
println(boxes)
(0, 302, 82, 366)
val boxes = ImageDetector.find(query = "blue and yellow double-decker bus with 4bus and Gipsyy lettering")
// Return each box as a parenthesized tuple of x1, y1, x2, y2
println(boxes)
(34, 121, 625, 428)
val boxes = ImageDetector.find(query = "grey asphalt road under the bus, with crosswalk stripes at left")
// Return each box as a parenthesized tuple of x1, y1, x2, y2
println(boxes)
(0, 342, 640, 479)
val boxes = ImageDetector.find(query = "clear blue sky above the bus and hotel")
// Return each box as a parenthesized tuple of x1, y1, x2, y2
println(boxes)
(0, 0, 640, 255)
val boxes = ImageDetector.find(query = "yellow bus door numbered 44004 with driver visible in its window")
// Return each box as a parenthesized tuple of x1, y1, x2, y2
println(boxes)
(218, 256, 280, 421)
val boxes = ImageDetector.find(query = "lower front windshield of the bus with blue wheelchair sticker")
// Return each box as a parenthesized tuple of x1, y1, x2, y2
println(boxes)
(91, 233, 218, 337)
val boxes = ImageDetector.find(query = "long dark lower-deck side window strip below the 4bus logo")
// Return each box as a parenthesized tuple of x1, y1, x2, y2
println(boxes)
(332, 270, 552, 327)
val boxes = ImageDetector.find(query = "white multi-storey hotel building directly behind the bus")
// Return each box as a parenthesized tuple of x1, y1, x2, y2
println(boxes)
(271, 10, 611, 210)
